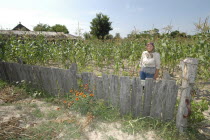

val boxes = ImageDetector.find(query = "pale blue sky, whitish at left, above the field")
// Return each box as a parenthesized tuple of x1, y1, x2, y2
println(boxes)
(0, 0, 210, 37)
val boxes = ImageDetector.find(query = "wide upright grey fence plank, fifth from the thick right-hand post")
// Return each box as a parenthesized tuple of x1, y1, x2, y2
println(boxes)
(120, 76, 131, 115)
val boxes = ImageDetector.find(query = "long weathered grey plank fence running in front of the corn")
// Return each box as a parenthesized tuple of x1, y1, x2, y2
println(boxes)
(0, 62, 178, 120)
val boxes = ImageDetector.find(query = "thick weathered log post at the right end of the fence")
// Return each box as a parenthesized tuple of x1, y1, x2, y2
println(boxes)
(176, 58, 198, 133)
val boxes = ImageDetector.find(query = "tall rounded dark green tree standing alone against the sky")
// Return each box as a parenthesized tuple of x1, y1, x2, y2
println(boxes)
(90, 13, 113, 39)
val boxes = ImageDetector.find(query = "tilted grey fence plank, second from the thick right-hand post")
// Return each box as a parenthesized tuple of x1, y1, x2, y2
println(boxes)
(150, 80, 167, 119)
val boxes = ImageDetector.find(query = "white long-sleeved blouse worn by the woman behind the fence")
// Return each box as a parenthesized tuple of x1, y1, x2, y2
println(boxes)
(140, 51, 160, 69)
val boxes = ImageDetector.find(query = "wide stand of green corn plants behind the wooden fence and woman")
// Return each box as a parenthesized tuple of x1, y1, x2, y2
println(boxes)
(0, 34, 210, 80)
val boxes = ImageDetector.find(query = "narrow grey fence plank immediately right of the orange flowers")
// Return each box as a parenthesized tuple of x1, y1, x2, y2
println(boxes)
(96, 77, 104, 99)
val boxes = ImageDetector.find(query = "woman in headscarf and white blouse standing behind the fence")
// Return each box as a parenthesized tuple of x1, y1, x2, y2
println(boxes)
(140, 42, 160, 80)
